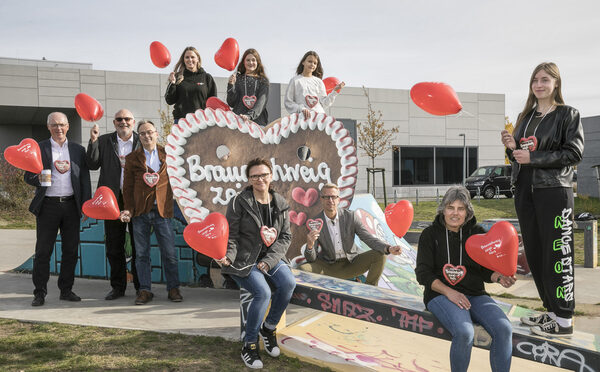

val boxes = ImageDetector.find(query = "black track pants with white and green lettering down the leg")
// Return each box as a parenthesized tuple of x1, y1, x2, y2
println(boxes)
(515, 183, 575, 318)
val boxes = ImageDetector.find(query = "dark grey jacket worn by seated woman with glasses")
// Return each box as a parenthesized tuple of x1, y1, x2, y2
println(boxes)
(221, 187, 292, 277)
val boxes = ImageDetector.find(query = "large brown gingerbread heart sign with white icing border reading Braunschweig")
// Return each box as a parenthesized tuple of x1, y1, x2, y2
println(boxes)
(165, 109, 358, 257)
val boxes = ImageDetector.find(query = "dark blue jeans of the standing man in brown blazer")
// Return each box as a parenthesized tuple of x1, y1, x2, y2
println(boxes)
(131, 208, 179, 291)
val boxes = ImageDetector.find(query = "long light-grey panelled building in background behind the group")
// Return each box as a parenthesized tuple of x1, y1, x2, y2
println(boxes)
(0, 58, 504, 198)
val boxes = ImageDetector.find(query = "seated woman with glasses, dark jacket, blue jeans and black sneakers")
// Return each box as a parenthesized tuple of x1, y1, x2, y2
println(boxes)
(219, 158, 296, 368)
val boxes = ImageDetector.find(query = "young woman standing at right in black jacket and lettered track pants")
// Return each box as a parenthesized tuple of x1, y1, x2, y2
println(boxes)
(501, 62, 584, 337)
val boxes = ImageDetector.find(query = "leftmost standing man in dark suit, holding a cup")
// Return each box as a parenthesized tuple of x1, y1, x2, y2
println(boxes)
(25, 112, 92, 306)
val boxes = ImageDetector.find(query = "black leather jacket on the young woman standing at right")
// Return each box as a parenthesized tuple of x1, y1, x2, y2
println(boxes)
(506, 105, 584, 188)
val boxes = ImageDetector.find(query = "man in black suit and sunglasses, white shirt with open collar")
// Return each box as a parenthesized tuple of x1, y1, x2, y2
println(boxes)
(86, 109, 140, 300)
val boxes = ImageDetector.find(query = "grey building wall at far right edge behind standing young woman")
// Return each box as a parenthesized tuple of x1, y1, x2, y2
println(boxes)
(577, 116, 600, 198)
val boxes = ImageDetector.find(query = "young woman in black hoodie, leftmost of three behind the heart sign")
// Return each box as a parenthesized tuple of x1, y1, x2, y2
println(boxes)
(165, 46, 217, 123)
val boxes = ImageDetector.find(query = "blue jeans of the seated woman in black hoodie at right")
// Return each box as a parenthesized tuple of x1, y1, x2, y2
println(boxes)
(427, 295, 512, 372)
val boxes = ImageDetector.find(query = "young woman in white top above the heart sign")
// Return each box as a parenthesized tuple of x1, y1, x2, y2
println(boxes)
(284, 50, 346, 118)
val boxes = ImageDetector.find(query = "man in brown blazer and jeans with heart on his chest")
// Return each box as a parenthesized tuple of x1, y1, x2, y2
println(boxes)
(121, 120, 183, 305)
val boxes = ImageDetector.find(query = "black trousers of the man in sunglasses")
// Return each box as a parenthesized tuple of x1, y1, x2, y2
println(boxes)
(104, 192, 140, 292)
